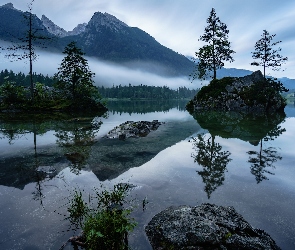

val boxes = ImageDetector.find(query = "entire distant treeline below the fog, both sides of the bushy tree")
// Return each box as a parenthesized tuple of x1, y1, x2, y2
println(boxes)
(0, 69, 198, 99)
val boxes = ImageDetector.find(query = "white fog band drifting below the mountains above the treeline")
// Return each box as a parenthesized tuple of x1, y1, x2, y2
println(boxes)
(0, 42, 202, 89)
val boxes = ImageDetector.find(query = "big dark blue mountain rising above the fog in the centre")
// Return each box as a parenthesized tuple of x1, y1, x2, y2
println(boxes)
(70, 12, 197, 76)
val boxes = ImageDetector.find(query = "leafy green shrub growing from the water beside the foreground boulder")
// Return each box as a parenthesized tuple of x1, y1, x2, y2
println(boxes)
(67, 184, 136, 250)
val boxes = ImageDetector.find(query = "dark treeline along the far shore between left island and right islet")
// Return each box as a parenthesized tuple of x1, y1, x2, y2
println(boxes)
(98, 84, 198, 99)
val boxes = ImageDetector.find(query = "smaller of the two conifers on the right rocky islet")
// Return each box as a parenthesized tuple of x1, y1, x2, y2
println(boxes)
(251, 30, 288, 78)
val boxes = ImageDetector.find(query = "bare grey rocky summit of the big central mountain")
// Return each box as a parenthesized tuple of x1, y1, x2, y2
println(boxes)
(88, 12, 128, 31)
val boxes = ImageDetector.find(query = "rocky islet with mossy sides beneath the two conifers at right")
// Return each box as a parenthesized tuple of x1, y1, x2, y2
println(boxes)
(187, 71, 287, 113)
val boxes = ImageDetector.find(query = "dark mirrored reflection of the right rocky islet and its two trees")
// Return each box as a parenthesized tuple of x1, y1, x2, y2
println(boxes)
(192, 110, 286, 194)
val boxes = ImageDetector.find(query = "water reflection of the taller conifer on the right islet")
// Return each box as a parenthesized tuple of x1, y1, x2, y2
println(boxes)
(192, 134, 231, 199)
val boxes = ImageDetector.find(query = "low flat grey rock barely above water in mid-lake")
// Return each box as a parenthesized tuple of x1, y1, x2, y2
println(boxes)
(106, 120, 163, 140)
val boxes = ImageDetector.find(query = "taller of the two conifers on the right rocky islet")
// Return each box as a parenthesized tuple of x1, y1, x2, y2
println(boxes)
(192, 8, 235, 80)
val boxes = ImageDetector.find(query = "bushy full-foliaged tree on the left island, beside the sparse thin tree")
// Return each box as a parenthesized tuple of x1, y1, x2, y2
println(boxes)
(55, 42, 100, 109)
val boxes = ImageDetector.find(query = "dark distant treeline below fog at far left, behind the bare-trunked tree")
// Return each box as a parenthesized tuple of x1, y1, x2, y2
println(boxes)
(0, 69, 54, 87)
